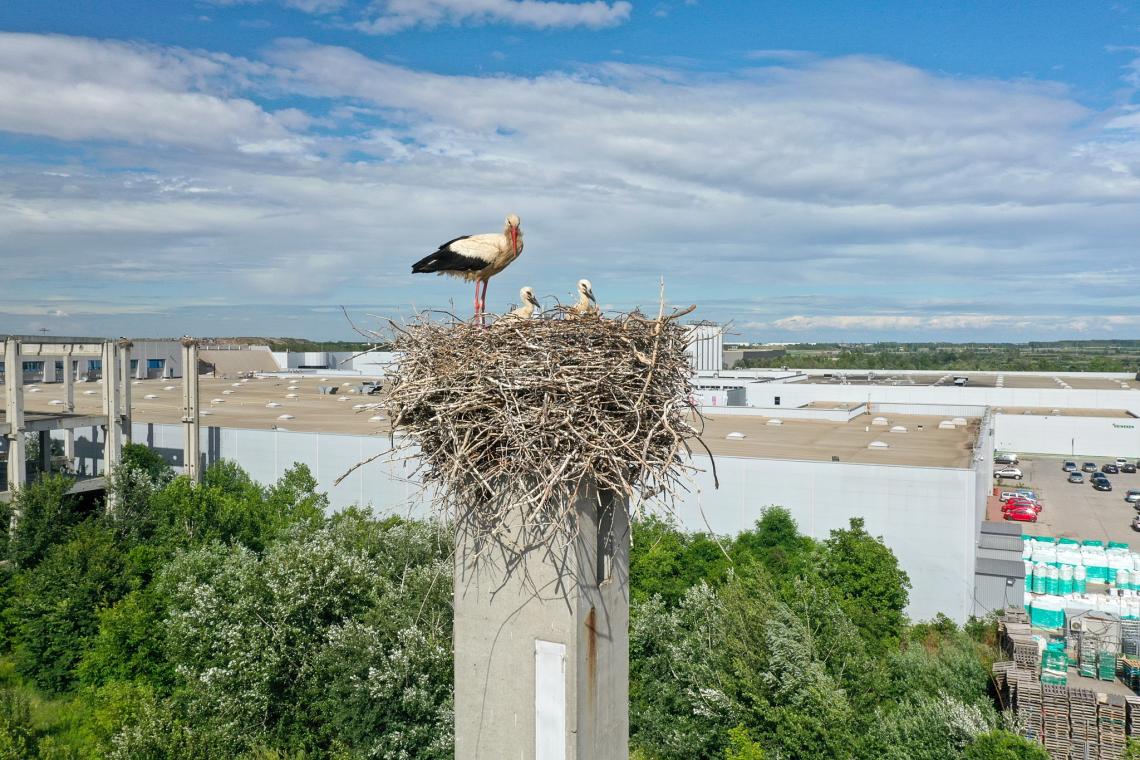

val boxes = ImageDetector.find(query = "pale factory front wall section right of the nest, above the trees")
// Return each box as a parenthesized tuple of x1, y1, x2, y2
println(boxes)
(677, 457, 975, 622)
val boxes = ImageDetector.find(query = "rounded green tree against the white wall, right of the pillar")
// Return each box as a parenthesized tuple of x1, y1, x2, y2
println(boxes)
(820, 517, 911, 651)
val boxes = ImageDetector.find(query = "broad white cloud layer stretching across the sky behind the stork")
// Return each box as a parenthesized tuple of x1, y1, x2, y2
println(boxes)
(0, 35, 1140, 335)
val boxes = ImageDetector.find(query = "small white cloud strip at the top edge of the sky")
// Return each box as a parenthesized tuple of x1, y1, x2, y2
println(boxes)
(356, 0, 633, 34)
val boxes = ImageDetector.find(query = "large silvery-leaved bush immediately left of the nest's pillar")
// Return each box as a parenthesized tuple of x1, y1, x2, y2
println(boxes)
(112, 510, 453, 759)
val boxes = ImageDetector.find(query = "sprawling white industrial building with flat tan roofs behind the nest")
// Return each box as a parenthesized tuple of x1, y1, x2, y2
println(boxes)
(14, 324, 1140, 621)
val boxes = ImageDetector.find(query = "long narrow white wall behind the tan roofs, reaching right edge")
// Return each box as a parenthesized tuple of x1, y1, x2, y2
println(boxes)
(748, 383, 1140, 410)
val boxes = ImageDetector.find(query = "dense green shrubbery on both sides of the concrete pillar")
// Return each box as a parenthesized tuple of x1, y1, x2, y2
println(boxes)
(0, 447, 1016, 760)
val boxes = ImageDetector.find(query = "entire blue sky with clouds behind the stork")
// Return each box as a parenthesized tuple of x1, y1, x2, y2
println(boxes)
(0, 0, 1140, 341)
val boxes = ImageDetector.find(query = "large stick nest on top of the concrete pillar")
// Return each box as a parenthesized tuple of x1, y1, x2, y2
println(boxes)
(385, 308, 703, 550)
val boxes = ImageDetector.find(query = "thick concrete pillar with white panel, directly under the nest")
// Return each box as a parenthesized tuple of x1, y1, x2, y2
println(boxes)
(455, 485, 629, 760)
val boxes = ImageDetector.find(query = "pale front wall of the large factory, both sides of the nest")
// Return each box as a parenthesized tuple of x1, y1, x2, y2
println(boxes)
(127, 423, 990, 622)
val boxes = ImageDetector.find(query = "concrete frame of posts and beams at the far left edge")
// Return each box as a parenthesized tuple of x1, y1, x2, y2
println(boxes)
(0, 335, 131, 526)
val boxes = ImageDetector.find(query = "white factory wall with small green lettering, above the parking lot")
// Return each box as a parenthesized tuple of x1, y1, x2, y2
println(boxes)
(995, 414, 1140, 458)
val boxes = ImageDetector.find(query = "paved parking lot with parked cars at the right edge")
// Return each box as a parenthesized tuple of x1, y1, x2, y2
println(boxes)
(991, 457, 1140, 547)
